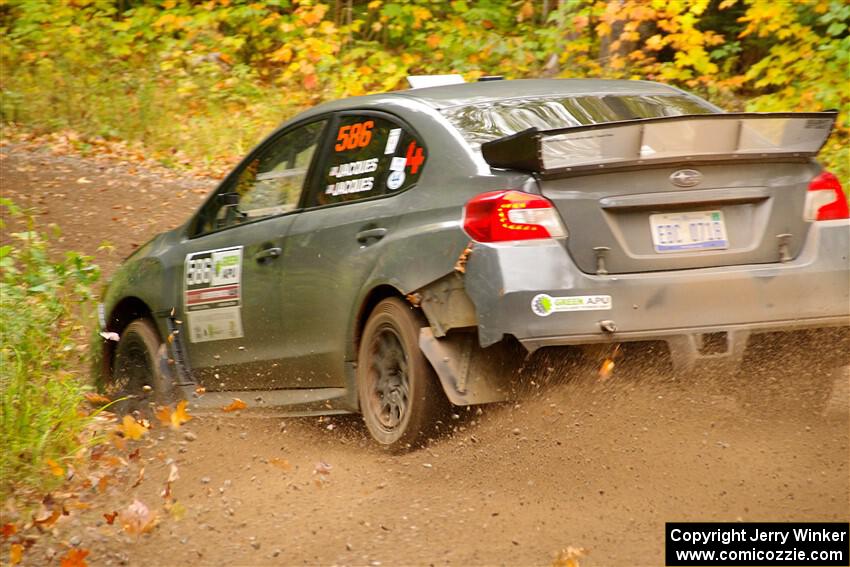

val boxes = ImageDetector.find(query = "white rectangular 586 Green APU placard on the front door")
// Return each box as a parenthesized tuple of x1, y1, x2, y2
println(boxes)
(184, 246, 243, 343)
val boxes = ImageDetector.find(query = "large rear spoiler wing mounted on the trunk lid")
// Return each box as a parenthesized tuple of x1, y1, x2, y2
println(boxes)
(481, 110, 838, 176)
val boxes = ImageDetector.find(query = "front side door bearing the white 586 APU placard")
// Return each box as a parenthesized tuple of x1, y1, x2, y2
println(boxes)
(182, 120, 326, 390)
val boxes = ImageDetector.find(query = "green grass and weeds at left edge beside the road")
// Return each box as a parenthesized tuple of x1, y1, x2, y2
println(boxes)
(0, 199, 99, 500)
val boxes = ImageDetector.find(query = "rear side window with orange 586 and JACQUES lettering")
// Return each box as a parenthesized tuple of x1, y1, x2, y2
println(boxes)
(306, 114, 427, 207)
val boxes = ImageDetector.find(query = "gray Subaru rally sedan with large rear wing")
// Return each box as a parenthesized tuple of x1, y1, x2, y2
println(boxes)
(99, 80, 850, 448)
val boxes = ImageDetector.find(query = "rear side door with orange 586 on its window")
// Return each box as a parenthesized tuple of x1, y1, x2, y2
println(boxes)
(283, 111, 426, 387)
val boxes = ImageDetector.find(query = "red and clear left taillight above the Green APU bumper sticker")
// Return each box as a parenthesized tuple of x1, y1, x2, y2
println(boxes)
(463, 191, 567, 242)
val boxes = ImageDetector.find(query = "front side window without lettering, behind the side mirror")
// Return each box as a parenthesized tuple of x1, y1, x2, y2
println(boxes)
(196, 120, 326, 234)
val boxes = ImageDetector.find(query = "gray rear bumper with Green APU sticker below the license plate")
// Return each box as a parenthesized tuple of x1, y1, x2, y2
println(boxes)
(466, 220, 850, 358)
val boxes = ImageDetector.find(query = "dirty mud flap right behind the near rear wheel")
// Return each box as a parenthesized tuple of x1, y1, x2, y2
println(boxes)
(419, 327, 526, 406)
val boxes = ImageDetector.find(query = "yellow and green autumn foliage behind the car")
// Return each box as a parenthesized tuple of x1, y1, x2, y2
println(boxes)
(0, 0, 850, 184)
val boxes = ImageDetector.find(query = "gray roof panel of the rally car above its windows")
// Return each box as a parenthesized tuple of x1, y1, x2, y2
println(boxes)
(300, 79, 692, 117)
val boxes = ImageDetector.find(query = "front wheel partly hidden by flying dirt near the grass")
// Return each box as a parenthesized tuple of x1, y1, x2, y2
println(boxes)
(107, 319, 171, 413)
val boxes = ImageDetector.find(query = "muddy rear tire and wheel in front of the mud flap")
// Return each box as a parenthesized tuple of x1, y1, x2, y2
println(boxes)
(357, 298, 447, 452)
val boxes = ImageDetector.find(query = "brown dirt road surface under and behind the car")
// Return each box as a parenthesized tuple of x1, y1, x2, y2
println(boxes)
(0, 146, 850, 567)
